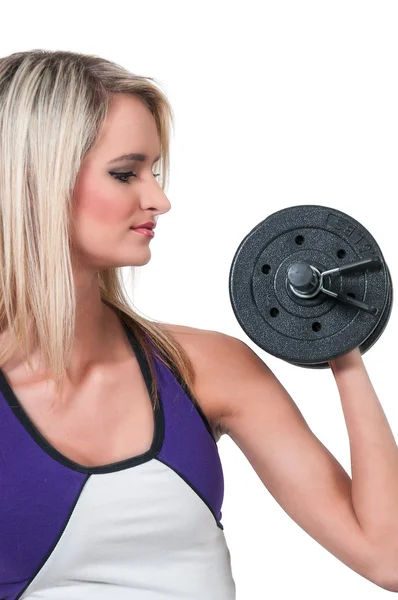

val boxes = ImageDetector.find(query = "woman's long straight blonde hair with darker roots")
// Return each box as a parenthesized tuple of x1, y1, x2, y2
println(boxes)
(0, 49, 194, 410)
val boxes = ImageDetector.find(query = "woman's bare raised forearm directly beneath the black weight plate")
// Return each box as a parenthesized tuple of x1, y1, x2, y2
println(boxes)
(330, 350, 398, 552)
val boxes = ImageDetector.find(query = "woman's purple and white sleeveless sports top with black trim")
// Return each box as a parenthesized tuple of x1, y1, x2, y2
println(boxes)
(0, 321, 235, 600)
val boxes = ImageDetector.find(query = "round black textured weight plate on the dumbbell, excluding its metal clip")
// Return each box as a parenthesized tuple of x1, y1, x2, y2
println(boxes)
(229, 205, 392, 368)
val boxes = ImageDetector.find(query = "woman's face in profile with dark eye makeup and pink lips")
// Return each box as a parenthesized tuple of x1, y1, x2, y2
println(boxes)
(72, 95, 171, 271)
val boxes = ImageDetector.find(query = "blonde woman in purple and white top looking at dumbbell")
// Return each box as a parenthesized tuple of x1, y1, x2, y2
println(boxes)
(0, 50, 398, 600)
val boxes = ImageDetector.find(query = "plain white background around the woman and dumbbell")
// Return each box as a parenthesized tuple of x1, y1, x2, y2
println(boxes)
(0, 0, 398, 600)
